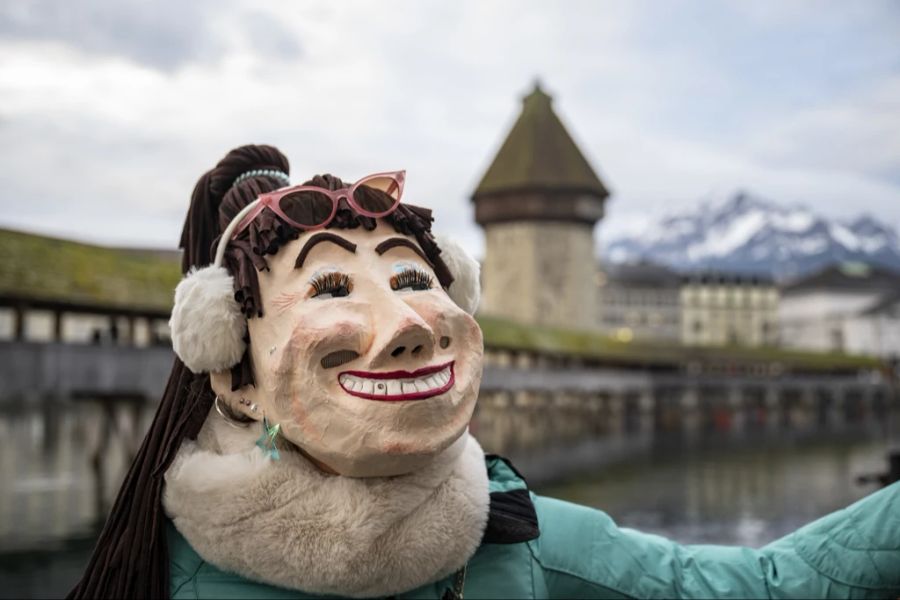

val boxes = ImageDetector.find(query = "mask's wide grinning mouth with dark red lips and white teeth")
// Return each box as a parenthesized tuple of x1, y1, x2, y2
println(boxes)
(338, 361, 456, 402)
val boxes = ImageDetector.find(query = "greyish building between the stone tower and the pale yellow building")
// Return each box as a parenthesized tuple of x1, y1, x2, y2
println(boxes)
(597, 262, 682, 343)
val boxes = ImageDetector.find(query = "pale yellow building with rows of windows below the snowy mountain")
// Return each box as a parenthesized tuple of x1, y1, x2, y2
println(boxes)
(680, 272, 779, 347)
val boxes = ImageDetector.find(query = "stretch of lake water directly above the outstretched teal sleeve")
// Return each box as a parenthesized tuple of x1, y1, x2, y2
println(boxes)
(526, 429, 885, 547)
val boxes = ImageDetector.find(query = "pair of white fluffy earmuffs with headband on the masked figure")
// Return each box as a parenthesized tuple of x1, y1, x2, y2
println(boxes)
(169, 199, 481, 373)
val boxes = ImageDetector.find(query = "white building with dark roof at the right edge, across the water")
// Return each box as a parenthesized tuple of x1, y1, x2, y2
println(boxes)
(780, 263, 900, 358)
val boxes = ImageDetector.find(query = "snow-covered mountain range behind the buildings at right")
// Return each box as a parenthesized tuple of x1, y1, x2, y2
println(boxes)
(601, 192, 900, 279)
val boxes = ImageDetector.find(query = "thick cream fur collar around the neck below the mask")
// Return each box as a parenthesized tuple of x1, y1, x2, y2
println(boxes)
(163, 413, 490, 597)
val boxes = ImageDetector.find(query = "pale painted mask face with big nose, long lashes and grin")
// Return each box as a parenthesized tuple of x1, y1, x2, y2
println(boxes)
(221, 222, 483, 477)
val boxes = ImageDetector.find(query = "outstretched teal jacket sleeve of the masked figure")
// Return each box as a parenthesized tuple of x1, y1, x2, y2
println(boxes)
(529, 483, 900, 598)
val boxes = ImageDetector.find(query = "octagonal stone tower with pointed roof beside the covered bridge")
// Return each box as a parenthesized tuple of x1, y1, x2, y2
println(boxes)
(472, 84, 609, 329)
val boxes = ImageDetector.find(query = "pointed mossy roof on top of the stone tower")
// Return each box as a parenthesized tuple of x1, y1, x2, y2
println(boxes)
(473, 85, 609, 198)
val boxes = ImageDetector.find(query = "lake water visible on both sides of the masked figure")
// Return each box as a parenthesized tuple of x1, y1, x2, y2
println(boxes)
(0, 406, 887, 598)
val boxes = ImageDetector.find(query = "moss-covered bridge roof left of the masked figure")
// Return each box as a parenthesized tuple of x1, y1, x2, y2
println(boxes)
(0, 229, 181, 314)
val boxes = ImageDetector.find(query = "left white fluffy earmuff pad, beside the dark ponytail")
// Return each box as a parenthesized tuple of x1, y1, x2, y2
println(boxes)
(169, 265, 247, 373)
